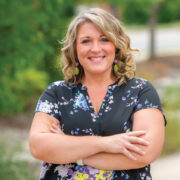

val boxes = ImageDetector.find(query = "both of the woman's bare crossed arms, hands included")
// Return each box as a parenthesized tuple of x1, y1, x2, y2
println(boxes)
(29, 108, 164, 170)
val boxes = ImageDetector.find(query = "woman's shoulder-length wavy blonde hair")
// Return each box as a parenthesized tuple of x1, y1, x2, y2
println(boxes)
(61, 8, 137, 85)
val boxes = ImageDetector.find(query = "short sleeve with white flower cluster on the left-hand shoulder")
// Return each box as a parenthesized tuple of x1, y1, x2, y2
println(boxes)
(35, 83, 60, 119)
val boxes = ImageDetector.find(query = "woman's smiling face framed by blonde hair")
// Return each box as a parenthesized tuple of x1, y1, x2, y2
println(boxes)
(76, 22, 116, 76)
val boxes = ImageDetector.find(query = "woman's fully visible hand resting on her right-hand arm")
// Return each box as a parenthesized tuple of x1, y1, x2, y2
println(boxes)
(102, 131, 149, 160)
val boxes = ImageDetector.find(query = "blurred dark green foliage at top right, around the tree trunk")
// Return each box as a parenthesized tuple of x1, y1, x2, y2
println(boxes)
(111, 0, 180, 24)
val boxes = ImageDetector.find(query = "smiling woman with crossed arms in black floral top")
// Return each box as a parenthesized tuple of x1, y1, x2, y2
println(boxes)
(30, 8, 164, 180)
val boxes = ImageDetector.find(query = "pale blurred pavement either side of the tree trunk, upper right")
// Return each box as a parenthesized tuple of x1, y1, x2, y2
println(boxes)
(126, 26, 180, 62)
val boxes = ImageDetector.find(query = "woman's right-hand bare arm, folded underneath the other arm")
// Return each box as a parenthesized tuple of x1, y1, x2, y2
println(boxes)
(84, 109, 164, 170)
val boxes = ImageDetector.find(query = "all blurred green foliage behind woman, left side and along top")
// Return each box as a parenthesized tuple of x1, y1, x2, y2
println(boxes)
(0, 0, 180, 115)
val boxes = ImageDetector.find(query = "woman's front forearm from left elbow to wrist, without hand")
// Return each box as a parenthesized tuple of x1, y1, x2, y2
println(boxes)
(30, 133, 103, 164)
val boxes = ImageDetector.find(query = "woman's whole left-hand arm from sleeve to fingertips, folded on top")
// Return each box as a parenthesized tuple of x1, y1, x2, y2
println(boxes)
(29, 113, 148, 164)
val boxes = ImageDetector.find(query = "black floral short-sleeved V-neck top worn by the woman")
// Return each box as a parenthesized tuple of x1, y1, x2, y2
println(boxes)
(36, 78, 165, 180)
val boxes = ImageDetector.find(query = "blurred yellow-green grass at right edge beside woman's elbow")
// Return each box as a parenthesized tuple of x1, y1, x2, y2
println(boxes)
(162, 86, 180, 155)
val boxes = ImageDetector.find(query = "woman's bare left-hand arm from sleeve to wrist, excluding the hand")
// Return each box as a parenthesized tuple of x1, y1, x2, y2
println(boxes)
(29, 112, 107, 164)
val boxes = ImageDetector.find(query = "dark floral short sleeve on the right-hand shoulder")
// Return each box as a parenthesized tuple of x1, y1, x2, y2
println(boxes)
(134, 81, 166, 124)
